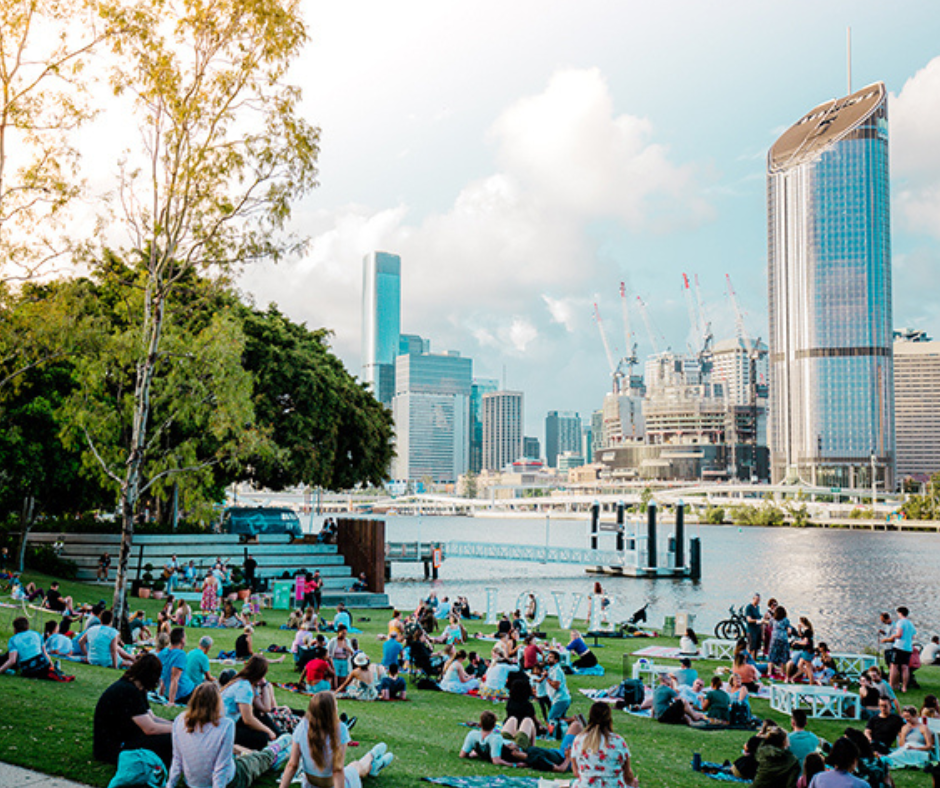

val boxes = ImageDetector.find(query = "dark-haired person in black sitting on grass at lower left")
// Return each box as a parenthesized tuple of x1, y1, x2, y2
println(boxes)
(92, 654, 173, 766)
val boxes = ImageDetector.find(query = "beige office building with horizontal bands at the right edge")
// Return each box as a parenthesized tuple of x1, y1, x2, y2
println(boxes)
(894, 331, 940, 479)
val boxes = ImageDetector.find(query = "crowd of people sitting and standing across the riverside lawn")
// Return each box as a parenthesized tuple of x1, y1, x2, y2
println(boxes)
(0, 566, 940, 788)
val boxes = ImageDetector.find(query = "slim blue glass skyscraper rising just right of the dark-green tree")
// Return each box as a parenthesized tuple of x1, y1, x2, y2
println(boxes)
(362, 252, 401, 406)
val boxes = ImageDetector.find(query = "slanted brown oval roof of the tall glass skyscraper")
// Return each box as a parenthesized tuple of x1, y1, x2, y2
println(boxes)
(767, 82, 885, 173)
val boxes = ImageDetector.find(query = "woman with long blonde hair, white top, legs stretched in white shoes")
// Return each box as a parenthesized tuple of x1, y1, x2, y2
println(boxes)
(280, 691, 394, 788)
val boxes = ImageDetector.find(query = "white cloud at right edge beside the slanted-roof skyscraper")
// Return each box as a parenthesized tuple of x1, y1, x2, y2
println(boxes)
(890, 57, 940, 236)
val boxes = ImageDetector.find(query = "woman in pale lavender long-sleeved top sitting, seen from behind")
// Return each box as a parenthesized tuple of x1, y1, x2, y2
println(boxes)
(167, 684, 291, 788)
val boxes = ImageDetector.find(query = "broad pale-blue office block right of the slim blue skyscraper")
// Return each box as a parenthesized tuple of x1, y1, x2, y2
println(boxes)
(392, 352, 473, 482)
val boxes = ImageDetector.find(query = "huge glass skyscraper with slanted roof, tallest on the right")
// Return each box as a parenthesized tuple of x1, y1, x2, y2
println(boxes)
(767, 83, 895, 489)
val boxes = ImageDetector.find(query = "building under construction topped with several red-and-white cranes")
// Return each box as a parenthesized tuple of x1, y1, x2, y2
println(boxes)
(595, 278, 769, 481)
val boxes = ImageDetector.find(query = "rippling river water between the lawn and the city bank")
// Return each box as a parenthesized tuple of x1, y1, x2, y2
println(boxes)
(358, 516, 940, 651)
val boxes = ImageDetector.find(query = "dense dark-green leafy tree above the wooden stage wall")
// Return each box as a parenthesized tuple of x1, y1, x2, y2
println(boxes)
(241, 305, 394, 490)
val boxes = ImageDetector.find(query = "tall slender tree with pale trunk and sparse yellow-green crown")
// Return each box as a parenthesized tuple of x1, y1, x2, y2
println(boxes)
(89, 0, 318, 619)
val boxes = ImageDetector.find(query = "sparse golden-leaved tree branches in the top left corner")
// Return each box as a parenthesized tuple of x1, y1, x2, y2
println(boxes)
(0, 0, 111, 279)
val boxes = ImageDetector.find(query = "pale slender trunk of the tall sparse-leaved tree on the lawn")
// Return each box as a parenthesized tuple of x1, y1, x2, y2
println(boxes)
(112, 284, 164, 631)
